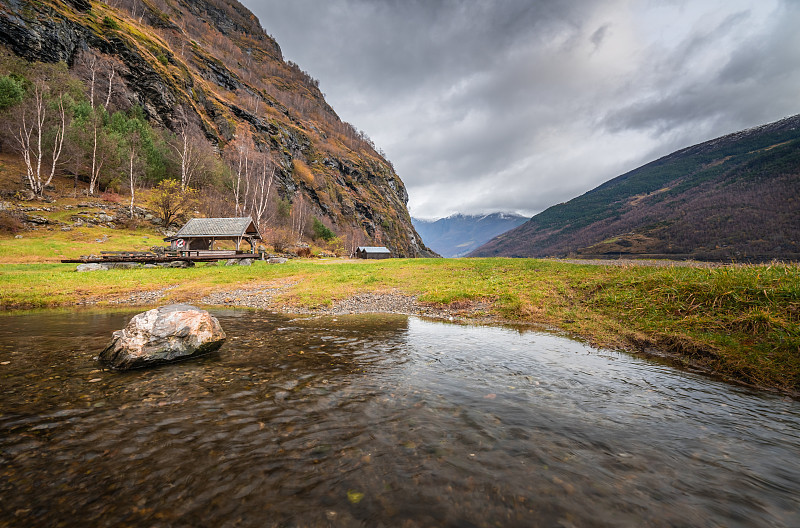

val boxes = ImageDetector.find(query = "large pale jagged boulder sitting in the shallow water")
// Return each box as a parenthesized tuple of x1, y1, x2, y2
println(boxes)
(98, 304, 226, 370)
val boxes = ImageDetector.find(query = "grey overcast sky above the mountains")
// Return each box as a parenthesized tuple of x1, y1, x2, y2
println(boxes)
(243, 0, 800, 218)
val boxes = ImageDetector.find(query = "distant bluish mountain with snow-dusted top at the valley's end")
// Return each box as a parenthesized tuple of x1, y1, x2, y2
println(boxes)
(411, 213, 527, 257)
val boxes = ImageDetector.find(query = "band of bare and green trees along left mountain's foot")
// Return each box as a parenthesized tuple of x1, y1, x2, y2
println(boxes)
(0, 52, 350, 252)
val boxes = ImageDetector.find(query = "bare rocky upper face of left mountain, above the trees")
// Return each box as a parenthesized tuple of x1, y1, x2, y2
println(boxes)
(0, 0, 432, 257)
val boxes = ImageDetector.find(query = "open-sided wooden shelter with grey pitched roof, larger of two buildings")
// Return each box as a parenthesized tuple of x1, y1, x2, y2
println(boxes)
(164, 216, 262, 253)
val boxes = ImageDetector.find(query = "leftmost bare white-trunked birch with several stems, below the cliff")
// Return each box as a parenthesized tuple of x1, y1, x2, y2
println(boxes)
(16, 81, 67, 196)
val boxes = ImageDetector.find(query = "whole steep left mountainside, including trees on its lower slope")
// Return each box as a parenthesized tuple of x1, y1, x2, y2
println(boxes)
(0, 0, 431, 257)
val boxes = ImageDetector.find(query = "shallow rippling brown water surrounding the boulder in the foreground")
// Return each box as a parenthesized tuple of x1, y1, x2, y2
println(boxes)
(0, 311, 800, 527)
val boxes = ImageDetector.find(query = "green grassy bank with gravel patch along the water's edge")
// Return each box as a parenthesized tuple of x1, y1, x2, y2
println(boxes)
(0, 259, 800, 394)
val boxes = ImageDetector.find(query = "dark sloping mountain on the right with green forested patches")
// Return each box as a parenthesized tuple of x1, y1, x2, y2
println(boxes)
(470, 116, 800, 261)
